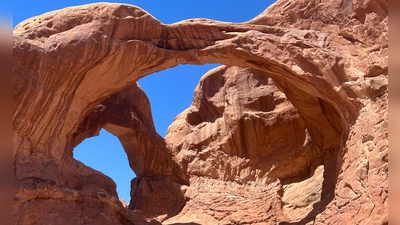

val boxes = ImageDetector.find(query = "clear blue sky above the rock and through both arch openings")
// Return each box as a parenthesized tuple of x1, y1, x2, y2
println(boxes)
(12, 0, 274, 203)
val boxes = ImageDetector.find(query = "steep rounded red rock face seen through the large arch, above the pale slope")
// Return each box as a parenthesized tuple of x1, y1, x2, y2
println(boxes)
(165, 66, 316, 184)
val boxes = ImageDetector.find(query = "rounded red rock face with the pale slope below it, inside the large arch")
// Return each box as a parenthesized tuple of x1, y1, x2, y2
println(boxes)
(162, 66, 322, 224)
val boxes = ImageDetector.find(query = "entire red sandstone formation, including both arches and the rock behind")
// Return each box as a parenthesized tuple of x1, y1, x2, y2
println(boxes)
(13, 0, 388, 224)
